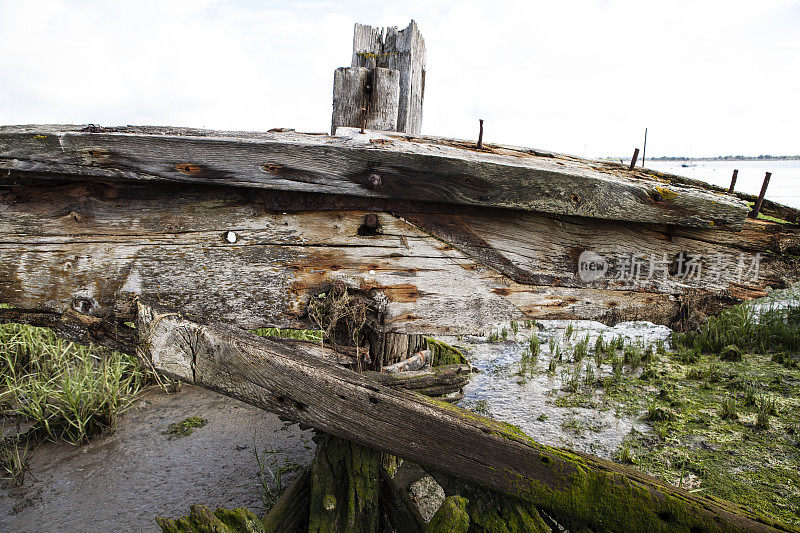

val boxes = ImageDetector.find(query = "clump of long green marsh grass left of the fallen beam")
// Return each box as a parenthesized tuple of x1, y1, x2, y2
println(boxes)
(0, 325, 149, 444)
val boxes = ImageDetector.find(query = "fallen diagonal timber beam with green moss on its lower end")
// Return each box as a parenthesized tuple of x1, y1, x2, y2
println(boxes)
(131, 303, 793, 531)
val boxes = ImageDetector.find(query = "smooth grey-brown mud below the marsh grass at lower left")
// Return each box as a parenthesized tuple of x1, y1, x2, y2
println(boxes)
(0, 386, 314, 532)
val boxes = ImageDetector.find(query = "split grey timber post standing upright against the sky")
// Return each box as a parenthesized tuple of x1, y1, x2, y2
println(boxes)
(331, 20, 425, 134)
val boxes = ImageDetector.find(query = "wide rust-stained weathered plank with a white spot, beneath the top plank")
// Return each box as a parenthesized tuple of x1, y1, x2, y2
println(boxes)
(0, 180, 800, 332)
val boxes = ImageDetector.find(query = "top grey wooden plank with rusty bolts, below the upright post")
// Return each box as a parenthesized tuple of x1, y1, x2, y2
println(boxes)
(0, 126, 748, 228)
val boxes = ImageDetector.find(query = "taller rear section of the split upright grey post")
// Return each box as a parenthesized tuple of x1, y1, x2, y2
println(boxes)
(352, 20, 425, 134)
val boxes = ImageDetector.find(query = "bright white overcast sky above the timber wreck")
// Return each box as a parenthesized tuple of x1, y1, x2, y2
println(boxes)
(0, 0, 800, 157)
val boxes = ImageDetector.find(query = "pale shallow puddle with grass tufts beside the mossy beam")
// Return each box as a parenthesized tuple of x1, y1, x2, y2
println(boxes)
(454, 320, 672, 458)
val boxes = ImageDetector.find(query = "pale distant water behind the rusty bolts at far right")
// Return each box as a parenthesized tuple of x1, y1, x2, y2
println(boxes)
(645, 159, 800, 208)
